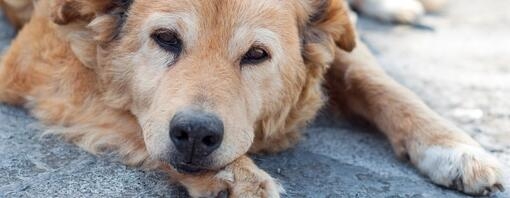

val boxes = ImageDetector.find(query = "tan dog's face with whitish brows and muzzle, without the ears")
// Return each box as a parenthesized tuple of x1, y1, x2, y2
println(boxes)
(117, 0, 304, 171)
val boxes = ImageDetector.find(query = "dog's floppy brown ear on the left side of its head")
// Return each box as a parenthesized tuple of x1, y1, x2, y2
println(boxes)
(51, 0, 133, 69)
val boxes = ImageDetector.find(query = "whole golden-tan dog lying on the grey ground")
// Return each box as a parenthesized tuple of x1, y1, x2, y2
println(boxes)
(0, 0, 504, 197)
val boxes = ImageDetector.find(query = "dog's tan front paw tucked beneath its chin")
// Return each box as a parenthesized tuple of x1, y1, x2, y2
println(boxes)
(176, 156, 283, 198)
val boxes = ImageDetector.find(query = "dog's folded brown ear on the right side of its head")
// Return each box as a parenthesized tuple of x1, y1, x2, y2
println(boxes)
(297, 0, 356, 64)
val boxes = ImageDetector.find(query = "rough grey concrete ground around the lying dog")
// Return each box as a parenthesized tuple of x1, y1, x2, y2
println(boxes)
(0, 0, 510, 198)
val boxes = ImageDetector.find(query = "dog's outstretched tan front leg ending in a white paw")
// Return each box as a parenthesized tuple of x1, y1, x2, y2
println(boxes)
(326, 42, 503, 195)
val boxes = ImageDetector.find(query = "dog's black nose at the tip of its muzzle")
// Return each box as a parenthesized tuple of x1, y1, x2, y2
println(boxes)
(170, 110, 223, 164)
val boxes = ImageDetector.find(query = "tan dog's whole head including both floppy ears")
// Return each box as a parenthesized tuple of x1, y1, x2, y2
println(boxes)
(53, 0, 355, 172)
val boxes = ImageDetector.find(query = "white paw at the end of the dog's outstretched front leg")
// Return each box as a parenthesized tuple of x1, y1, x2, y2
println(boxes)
(413, 144, 504, 195)
